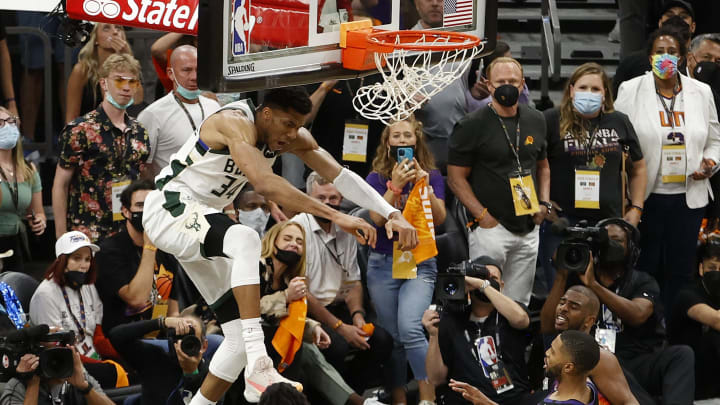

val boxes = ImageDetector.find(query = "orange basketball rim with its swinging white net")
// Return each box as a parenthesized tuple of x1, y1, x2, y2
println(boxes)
(353, 34, 484, 125)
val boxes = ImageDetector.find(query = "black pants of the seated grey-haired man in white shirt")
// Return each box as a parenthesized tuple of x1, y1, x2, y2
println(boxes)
(321, 304, 393, 392)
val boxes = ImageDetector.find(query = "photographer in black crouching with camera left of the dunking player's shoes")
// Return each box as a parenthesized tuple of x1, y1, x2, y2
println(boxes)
(109, 315, 208, 405)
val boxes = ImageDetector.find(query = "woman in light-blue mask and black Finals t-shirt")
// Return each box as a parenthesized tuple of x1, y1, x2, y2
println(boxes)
(540, 63, 647, 289)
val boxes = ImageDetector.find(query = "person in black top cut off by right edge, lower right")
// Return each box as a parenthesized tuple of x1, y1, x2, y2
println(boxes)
(668, 238, 720, 399)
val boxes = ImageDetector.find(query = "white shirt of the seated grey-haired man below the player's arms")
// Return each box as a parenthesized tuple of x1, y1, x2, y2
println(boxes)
(291, 214, 360, 305)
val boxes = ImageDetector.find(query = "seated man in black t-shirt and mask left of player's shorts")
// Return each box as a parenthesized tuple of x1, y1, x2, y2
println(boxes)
(95, 180, 179, 335)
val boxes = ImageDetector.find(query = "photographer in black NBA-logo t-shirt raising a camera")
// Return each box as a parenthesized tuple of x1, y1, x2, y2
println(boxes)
(422, 256, 530, 404)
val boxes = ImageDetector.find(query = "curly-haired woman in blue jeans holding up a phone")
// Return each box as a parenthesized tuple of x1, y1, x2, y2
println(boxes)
(367, 116, 446, 405)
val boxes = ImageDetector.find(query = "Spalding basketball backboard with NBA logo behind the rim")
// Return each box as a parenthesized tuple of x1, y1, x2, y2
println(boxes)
(198, 0, 497, 92)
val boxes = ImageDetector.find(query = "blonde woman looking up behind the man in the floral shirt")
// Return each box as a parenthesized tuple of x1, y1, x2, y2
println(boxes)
(65, 23, 143, 122)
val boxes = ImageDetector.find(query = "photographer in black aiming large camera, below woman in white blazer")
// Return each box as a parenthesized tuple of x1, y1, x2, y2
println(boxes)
(553, 218, 695, 404)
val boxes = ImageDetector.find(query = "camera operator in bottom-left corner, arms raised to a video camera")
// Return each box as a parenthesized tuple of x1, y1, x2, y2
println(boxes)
(0, 345, 114, 405)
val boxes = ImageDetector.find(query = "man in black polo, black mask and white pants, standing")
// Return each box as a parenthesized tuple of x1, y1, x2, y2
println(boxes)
(448, 57, 551, 305)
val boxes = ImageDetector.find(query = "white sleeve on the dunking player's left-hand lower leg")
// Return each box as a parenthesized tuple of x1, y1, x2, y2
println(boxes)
(209, 319, 247, 382)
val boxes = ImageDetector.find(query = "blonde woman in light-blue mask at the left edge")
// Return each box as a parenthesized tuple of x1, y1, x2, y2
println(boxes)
(0, 107, 47, 271)
